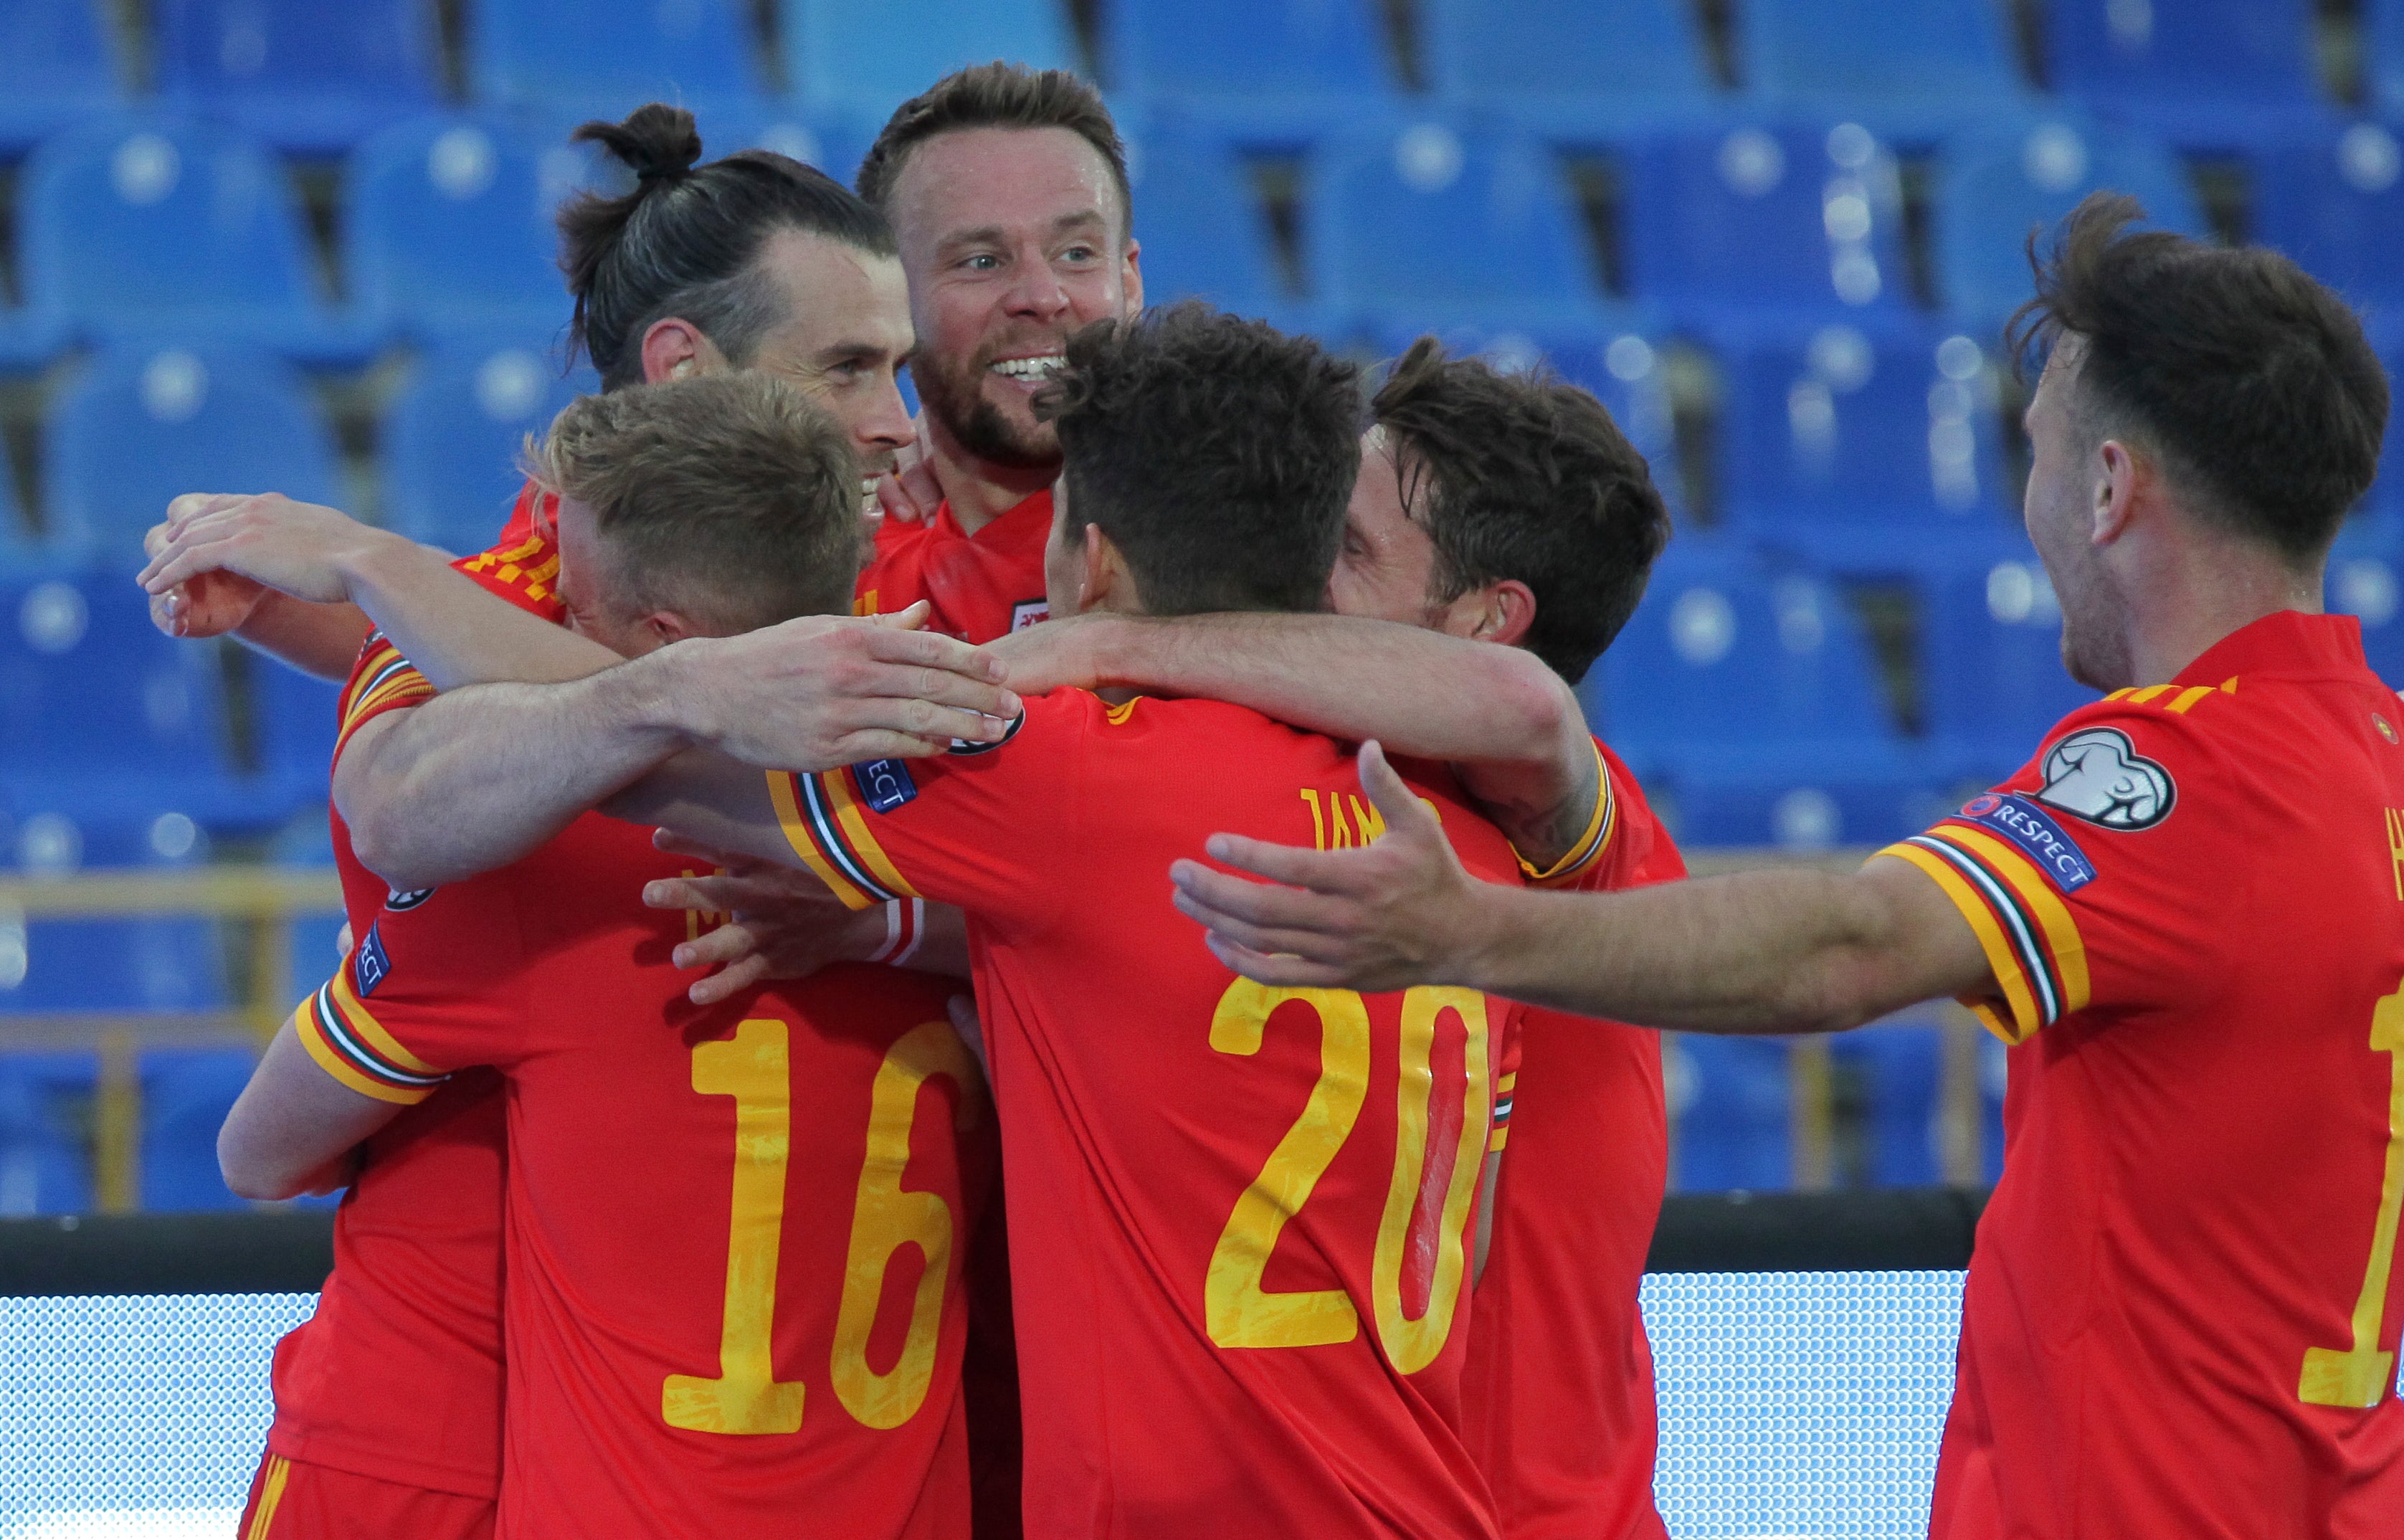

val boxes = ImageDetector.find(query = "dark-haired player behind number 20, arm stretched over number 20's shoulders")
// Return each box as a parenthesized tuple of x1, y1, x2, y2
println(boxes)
(995, 338, 1685, 1540)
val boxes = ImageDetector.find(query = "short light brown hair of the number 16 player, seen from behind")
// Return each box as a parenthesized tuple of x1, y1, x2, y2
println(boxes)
(526, 370, 860, 634)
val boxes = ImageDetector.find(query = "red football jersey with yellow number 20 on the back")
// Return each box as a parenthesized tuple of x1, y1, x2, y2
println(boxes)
(769, 690, 1519, 1540)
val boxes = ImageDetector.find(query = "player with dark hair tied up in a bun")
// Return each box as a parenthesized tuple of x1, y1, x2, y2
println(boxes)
(175, 108, 1004, 1538)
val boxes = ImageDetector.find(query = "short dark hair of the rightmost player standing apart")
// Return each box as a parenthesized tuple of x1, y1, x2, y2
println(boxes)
(2008, 192, 2388, 567)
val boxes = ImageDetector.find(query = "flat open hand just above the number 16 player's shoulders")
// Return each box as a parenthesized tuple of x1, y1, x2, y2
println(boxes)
(663, 601, 1020, 771)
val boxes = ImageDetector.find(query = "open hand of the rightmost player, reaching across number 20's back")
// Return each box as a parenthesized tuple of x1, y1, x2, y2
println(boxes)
(1173, 740, 1483, 992)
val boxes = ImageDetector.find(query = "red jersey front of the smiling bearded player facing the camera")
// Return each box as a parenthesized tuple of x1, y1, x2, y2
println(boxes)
(853, 488, 1050, 644)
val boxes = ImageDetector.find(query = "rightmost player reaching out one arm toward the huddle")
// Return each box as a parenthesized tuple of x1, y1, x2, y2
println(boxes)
(1176, 194, 2404, 1540)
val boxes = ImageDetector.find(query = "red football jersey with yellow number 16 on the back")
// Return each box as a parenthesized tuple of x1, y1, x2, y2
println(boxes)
(303, 814, 993, 1540)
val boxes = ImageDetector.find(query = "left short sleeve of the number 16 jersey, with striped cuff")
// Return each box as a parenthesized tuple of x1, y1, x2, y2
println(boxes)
(293, 879, 526, 1105)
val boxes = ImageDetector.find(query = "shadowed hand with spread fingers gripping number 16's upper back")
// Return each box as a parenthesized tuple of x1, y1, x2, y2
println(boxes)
(642, 829, 885, 1004)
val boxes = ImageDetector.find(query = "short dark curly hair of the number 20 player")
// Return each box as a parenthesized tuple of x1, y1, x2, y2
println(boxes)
(1036, 300, 1361, 615)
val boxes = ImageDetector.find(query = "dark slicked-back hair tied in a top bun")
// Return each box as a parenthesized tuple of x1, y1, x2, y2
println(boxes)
(558, 101, 899, 389)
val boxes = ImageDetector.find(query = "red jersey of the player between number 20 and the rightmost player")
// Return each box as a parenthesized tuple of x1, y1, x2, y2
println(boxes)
(1464, 742, 1685, 1540)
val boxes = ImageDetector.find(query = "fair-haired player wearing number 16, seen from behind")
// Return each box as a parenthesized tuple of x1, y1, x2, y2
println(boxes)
(221, 372, 993, 1540)
